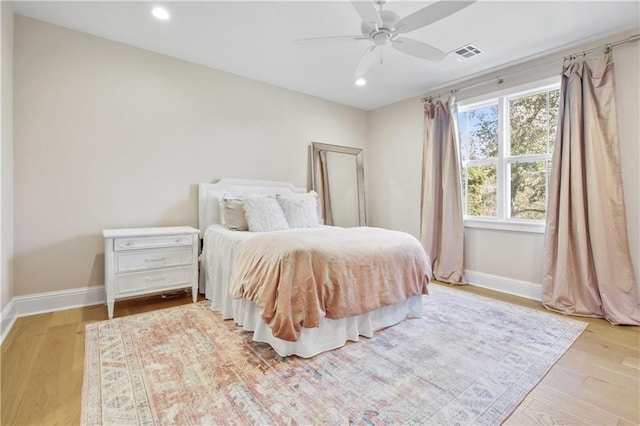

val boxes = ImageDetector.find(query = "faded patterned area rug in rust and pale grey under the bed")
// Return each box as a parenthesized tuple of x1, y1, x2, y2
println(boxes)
(81, 285, 586, 425)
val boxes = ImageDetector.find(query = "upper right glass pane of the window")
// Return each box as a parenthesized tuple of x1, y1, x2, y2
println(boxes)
(509, 92, 549, 155)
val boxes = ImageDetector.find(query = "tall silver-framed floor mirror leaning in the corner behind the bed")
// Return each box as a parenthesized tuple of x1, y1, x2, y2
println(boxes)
(311, 142, 367, 227)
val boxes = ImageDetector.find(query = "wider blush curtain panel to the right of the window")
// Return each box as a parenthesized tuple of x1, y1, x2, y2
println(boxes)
(542, 51, 640, 325)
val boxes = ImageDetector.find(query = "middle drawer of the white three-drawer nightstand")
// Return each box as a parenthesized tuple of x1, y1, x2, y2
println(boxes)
(116, 247, 193, 273)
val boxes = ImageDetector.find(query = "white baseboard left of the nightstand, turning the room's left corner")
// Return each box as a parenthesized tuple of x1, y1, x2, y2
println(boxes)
(0, 285, 106, 343)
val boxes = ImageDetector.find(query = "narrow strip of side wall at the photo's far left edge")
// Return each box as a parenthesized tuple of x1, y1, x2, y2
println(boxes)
(0, 1, 13, 312)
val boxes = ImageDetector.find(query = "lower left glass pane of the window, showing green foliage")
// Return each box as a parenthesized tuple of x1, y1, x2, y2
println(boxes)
(463, 165, 498, 217)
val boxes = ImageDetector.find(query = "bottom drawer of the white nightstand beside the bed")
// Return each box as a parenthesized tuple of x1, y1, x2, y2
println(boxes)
(115, 266, 193, 295)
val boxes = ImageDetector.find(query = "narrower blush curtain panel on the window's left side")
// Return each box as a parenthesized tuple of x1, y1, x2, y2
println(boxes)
(420, 97, 464, 284)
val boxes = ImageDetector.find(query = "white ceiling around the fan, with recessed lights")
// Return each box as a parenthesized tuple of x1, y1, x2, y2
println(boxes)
(13, 0, 640, 110)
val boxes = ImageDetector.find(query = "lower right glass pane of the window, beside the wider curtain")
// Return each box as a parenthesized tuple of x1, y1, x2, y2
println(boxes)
(510, 161, 547, 219)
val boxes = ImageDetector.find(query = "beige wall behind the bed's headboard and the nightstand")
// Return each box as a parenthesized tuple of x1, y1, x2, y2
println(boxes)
(14, 16, 367, 295)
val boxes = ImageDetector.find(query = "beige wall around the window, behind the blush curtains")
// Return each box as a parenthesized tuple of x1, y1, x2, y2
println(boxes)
(367, 30, 640, 290)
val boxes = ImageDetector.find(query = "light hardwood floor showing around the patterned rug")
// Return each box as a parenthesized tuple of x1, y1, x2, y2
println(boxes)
(0, 286, 640, 425)
